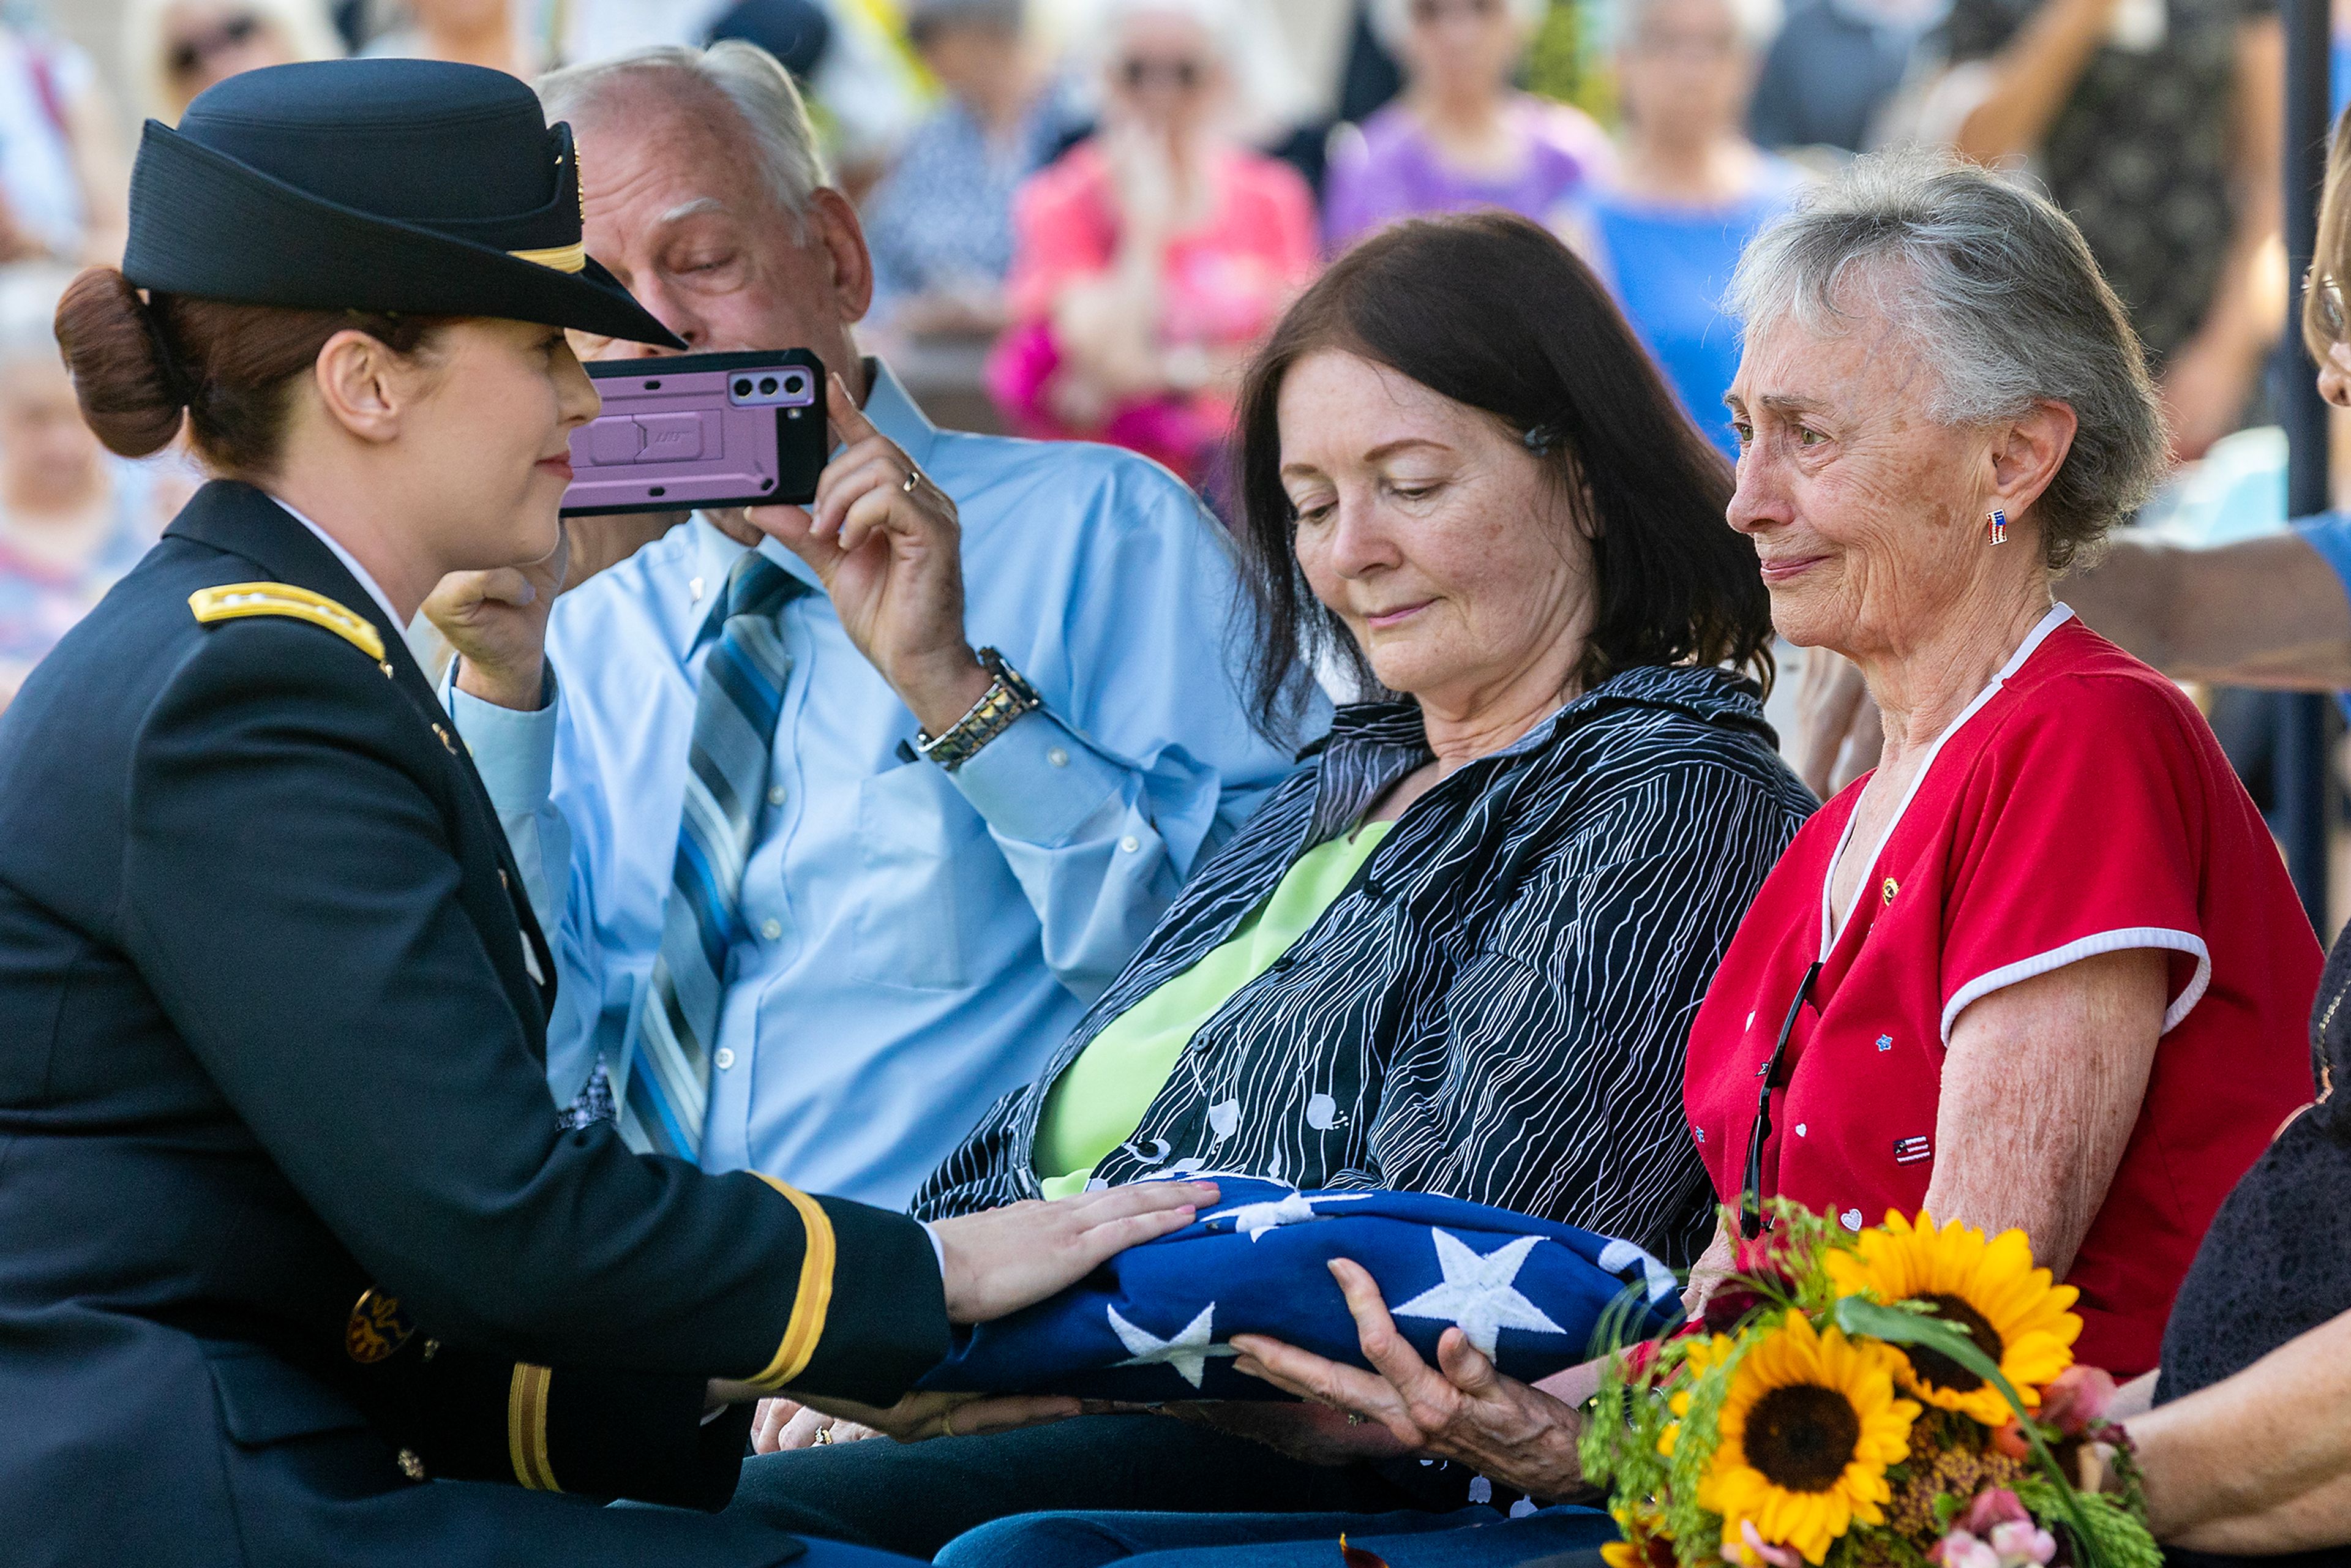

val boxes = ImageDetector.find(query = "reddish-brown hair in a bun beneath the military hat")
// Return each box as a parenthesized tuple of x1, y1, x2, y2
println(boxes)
(56, 266, 444, 479)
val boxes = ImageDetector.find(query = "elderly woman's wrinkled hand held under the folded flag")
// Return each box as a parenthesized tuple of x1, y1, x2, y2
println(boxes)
(1232, 1258, 1587, 1500)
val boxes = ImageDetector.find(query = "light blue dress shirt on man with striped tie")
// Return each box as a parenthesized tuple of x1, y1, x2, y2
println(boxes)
(444, 359, 1329, 1209)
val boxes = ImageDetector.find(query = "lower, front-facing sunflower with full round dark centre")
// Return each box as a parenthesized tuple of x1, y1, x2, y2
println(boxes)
(1697, 1311, 1918, 1563)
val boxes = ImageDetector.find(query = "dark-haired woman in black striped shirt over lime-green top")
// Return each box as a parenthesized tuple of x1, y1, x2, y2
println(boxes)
(736, 214, 1813, 1554)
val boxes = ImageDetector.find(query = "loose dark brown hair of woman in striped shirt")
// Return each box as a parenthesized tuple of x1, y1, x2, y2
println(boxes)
(1234, 212, 1772, 733)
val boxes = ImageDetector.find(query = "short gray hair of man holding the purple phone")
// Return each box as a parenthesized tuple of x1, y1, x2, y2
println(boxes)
(536, 37, 832, 240)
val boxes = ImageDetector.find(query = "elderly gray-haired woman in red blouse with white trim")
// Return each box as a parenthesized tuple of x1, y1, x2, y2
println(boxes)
(1683, 160, 2320, 1375)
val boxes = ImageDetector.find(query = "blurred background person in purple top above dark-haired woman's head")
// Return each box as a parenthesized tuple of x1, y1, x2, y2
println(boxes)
(1324, 0, 1613, 254)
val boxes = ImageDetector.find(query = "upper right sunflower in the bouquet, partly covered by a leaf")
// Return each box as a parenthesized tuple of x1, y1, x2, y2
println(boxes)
(1829, 1213, 2080, 1427)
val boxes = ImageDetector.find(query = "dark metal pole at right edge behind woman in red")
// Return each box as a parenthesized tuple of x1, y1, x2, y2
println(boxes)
(2276, 0, 2334, 938)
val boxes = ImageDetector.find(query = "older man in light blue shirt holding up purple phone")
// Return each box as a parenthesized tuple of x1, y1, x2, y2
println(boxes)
(435, 50, 1321, 1204)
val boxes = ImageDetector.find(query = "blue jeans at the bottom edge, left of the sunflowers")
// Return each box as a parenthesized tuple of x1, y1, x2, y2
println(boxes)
(938, 1507, 1618, 1568)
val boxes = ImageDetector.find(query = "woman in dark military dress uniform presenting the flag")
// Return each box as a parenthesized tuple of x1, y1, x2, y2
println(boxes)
(0, 61, 1211, 1568)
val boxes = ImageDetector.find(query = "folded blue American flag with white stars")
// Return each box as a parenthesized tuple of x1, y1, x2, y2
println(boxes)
(921, 1171, 1679, 1403)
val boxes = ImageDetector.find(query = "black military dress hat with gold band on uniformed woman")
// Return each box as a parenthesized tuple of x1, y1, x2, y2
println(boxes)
(122, 59, 684, 348)
